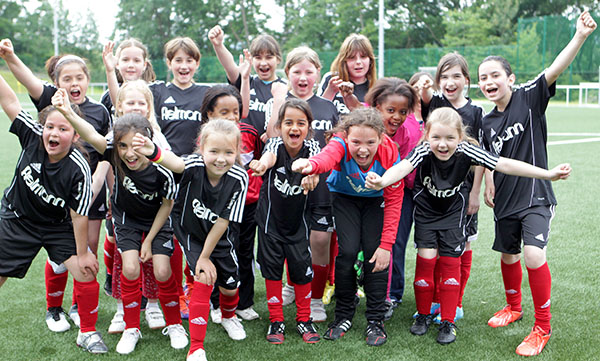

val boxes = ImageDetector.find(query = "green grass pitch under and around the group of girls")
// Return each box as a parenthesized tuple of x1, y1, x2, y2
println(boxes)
(0, 102, 600, 361)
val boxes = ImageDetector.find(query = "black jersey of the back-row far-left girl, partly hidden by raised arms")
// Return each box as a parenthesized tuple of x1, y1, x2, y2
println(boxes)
(31, 83, 112, 172)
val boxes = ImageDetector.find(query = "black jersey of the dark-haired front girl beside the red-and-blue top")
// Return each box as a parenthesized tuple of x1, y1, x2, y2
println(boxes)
(256, 137, 320, 243)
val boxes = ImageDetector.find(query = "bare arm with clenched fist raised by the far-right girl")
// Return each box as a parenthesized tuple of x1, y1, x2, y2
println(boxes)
(546, 11, 596, 86)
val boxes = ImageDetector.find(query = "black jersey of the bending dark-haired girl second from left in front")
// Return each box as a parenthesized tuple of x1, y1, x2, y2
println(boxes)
(104, 141, 177, 231)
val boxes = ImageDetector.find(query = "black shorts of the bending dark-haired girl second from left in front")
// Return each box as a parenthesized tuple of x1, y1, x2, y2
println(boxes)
(115, 221, 173, 257)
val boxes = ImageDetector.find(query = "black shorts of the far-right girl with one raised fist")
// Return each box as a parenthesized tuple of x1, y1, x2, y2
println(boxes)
(492, 205, 556, 254)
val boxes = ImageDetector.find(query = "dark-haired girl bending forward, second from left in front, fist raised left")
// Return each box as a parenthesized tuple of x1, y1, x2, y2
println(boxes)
(52, 89, 188, 354)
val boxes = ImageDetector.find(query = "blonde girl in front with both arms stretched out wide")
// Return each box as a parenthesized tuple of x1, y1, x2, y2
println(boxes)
(366, 108, 571, 344)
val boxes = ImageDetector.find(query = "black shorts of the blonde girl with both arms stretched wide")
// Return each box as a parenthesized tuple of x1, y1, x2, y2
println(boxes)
(415, 225, 467, 257)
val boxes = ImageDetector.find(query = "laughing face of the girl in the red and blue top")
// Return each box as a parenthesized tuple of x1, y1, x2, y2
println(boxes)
(347, 125, 381, 171)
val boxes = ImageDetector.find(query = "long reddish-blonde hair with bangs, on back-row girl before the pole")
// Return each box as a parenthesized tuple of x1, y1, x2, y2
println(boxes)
(331, 34, 377, 89)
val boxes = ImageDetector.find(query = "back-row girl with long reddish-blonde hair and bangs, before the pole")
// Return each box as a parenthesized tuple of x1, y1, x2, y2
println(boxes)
(318, 34, 377, 114)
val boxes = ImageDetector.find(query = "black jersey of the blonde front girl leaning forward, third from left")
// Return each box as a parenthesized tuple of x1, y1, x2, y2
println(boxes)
(174, 154, 248, 257)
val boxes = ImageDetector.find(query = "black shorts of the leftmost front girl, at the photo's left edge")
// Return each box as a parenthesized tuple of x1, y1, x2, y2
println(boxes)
(0, 218, 77, 278)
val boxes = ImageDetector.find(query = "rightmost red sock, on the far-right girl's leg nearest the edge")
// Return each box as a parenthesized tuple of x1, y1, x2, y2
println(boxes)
(527, 262, 552, 333)
